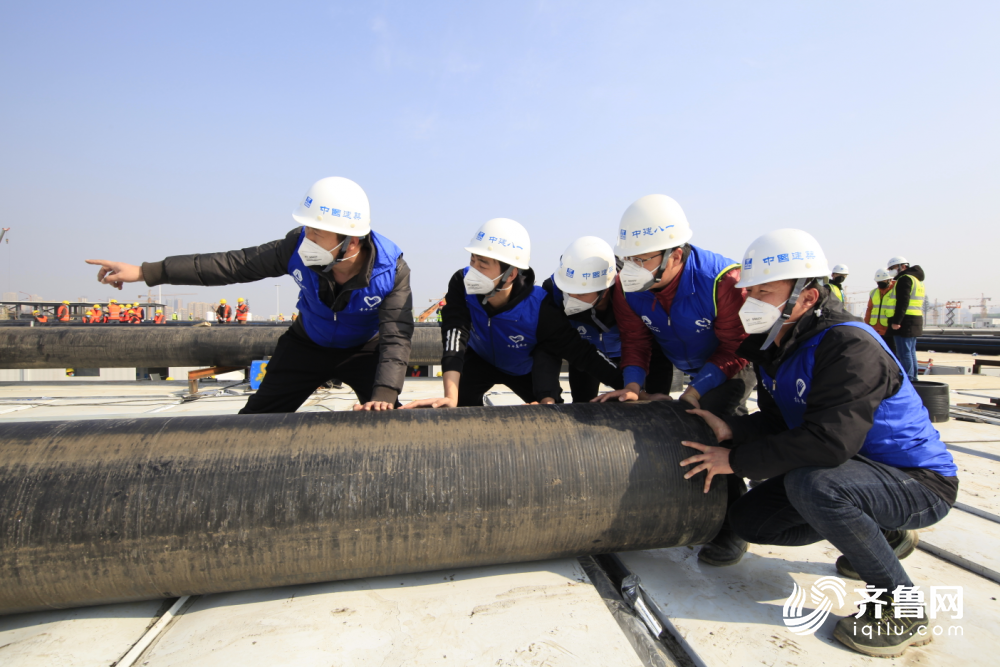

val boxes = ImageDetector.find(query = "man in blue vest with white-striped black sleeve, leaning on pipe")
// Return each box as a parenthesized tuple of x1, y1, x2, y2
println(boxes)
(404, 218, 622, 408)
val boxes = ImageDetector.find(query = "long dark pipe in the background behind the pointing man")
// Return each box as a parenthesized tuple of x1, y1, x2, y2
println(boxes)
(0, 324, 442, 368)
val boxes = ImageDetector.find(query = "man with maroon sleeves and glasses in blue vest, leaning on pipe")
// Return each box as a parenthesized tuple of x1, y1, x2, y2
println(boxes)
(597, 194, 754, 566)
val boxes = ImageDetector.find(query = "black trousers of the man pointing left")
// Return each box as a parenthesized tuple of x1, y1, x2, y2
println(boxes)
(240, 329, 378, 415)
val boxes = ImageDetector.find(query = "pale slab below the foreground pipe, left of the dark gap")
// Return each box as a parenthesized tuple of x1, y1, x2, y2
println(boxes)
(138, 559, 642, 667)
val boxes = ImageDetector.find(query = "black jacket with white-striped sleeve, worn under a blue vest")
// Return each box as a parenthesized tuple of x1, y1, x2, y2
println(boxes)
(441, 269, 624, 401)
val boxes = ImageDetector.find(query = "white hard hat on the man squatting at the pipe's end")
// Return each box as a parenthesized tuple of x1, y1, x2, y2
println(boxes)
(736, 229, 830, 287)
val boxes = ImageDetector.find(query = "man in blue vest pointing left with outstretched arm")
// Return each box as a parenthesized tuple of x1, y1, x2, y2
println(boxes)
(87, 176, 413, 414)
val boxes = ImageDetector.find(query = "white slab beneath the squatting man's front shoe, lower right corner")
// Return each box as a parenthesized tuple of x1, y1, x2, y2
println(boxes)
(620, 542, 1000, 667)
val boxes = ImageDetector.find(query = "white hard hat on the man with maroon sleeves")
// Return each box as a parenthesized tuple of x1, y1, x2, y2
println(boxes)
(615, 195, 691, 257)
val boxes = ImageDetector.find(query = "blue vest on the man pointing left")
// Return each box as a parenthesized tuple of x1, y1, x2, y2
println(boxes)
(288, 227, 403, 348)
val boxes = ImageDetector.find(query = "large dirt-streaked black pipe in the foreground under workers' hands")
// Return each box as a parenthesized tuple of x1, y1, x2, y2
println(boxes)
(0, 402, 726, 614)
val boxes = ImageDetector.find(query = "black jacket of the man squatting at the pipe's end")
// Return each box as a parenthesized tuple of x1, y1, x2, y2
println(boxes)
(726, 288, 958, 503)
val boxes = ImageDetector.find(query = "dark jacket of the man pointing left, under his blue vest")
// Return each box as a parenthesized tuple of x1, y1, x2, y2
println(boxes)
(142, 227, 413, 403)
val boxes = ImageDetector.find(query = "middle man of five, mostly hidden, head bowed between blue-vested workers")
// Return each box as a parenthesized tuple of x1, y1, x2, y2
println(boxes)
(535, 236, 673, 403)
